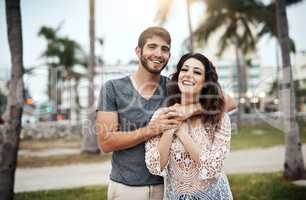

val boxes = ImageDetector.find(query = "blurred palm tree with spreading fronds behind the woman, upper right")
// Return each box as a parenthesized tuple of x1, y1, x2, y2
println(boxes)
(194, 0, 260, 127)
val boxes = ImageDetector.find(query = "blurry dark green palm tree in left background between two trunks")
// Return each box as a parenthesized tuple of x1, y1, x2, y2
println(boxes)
(39, 26, 87, 121)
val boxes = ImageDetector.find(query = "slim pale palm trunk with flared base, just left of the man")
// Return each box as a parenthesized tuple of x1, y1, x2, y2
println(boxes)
(81, 0, 100, 154)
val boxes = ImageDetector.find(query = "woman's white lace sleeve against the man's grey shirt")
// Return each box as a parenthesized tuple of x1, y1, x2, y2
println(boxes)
(145, 108, 168, 176)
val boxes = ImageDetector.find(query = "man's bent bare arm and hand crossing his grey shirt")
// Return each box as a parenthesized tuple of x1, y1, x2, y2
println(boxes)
(96, 111, 180, 153)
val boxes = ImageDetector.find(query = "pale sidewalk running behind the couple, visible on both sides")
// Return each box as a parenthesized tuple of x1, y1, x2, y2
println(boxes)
(15, 145, 306, 192)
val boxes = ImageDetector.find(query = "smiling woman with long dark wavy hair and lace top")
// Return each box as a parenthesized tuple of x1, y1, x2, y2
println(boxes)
(145, 53, 232, 200)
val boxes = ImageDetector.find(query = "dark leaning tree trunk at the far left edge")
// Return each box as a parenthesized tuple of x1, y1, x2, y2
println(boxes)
(0, 0, 24, 200)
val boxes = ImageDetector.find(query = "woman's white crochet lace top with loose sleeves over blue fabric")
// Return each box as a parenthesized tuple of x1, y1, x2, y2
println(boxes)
(145, 109, 232, 199)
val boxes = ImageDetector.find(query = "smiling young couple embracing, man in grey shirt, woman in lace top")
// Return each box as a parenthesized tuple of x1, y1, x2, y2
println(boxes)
(96, 27, 236, 200)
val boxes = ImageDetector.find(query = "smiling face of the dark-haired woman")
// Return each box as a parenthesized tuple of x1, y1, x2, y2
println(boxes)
(178, 58, 205, 96)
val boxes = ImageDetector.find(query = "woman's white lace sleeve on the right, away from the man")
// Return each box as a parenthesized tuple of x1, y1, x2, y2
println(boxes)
(200, 114, 231, 179)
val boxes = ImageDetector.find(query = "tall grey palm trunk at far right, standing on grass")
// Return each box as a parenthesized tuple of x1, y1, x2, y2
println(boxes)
(275, 0, 305, 180)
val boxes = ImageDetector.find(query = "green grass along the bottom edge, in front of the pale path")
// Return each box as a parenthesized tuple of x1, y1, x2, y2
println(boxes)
(15, 172, 306, 200)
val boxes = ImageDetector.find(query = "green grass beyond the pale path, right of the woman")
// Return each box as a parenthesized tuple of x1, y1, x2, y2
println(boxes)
(231, 122, 306, 150)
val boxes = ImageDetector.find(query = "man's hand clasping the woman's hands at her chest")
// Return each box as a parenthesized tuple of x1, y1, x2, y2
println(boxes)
(147, 108, 183, 135)
